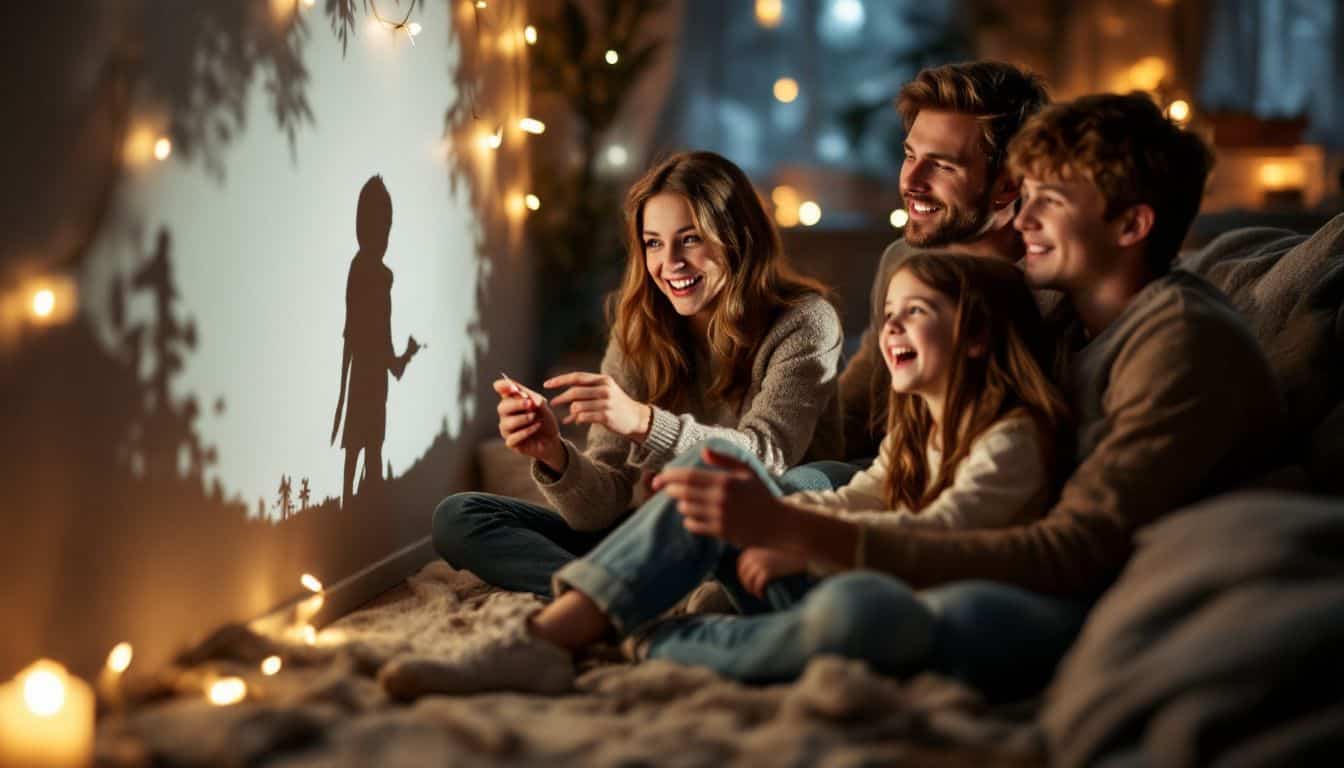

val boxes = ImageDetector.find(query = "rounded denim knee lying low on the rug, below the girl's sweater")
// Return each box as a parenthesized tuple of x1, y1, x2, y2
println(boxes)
(801, 572, 934, 673)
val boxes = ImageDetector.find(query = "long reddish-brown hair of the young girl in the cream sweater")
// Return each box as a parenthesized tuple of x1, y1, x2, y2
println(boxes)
(886, 252, 1071, 511)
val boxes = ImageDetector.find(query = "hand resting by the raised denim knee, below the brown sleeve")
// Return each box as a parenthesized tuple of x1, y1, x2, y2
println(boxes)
(653, 448, 793, 549)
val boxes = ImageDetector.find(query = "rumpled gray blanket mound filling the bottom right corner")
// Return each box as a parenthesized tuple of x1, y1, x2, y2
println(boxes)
(1042, 494, 1344, 765)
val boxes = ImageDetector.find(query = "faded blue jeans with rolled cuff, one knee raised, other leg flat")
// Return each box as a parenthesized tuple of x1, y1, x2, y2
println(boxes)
(556, 441, 1090, 699)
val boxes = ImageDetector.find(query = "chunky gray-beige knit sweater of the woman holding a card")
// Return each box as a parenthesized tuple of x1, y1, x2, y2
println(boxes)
(532, 296, 843, 530)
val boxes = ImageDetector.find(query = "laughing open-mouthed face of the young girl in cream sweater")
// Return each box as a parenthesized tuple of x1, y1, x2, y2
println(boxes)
(879, 269, 957, 413)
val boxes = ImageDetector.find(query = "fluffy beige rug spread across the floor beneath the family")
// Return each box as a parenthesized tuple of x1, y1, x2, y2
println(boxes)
(98, 564, 1044, 768)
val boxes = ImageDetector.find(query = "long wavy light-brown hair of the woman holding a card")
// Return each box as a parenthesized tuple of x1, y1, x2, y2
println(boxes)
(607, 152, 828, 408)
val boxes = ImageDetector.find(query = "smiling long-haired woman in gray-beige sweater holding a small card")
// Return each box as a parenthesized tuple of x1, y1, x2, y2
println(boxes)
(433, 152, 841, 594)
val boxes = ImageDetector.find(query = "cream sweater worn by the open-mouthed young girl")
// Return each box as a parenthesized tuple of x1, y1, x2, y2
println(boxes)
(785, 416, 1050, 530)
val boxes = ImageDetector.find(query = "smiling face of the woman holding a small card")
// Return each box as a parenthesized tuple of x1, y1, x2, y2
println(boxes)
(640, 192, 726, 324)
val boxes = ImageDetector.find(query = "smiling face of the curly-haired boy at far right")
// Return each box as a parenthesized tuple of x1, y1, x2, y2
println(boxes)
(1013, 176, 1121, 292)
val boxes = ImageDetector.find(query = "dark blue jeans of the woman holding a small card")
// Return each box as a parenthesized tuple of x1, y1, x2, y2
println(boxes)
(431, 451, 831, 597)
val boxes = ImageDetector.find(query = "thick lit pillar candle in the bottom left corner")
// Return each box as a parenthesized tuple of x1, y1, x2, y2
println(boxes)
(0, 659, 94, 768)
